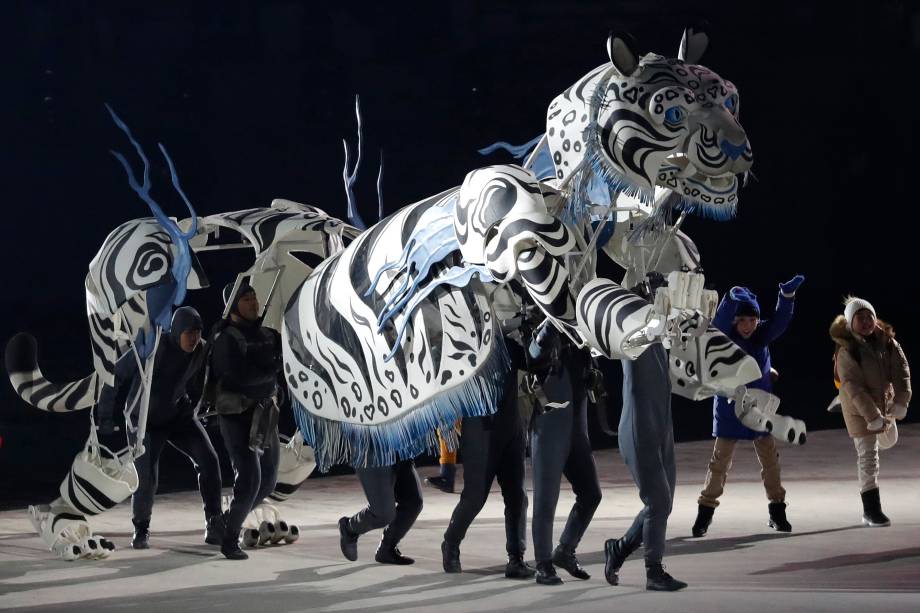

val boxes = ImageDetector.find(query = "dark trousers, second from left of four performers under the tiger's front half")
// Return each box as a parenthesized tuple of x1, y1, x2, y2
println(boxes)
(444, 414, 527, 556)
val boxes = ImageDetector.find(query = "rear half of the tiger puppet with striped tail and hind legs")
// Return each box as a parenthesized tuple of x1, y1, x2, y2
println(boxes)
(5, 109, 358, 560)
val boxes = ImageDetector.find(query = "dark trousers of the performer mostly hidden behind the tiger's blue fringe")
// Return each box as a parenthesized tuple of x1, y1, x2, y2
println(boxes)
(348, 460, 422, 547)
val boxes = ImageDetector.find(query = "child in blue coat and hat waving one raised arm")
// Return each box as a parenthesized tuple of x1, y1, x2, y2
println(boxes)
(692, 275, 805, 537)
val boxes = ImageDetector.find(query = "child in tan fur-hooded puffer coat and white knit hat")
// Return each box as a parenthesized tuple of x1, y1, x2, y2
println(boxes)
(830, 296, 911, 526)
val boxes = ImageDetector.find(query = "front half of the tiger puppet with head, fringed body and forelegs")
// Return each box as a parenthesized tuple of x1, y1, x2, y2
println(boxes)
(282, 31, 804, 470)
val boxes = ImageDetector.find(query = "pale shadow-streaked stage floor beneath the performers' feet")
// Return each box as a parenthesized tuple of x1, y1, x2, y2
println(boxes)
(0, 425, 920, 613)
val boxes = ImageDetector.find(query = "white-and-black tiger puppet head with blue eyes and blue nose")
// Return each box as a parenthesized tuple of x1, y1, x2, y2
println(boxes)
(547, 30, 753, 219)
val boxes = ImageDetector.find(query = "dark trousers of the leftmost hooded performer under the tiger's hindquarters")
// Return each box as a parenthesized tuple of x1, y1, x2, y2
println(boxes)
(131, 415, 221, 524)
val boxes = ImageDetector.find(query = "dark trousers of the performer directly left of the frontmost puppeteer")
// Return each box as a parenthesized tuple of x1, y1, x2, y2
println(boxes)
(530, 398, 601, 562)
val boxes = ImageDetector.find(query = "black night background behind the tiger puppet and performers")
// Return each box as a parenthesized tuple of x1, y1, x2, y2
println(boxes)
(0, 0, 920, 507)
